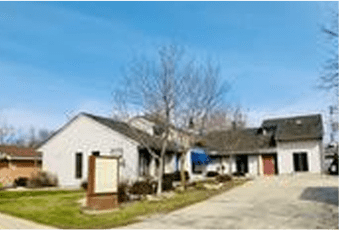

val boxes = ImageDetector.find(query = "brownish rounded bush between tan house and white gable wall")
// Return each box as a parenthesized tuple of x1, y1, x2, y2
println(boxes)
(27, 171, 58, 188)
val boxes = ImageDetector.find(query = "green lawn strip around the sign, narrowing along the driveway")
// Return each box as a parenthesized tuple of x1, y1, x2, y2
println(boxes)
(0, 181, 244, 229)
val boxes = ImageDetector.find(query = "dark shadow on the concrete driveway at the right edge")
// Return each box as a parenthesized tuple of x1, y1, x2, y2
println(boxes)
(299, 187, 339, 206)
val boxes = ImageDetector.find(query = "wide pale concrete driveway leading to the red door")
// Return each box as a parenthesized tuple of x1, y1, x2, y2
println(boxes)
(115, 174, 339, 229)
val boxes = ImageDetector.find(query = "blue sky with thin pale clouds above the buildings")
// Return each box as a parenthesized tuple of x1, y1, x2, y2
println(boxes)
(0, 1, 334, 142)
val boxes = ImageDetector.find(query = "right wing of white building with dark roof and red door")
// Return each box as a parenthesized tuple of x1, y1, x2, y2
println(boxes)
(188, 115, 324, 175)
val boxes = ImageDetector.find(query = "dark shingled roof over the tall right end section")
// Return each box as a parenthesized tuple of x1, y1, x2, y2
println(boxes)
(262, 114, 323, 141)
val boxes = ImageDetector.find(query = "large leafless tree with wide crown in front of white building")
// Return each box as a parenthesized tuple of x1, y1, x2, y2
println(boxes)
(113, 45, 228, 194)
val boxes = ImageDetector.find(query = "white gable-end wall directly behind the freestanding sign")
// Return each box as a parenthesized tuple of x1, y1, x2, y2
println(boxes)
(38, 115, 138, 187)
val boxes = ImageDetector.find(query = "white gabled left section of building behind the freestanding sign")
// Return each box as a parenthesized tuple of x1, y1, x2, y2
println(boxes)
(38, 113, 182, 187)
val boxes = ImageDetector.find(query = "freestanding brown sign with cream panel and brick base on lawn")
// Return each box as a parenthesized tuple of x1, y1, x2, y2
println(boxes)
(86, 156, 119, 210)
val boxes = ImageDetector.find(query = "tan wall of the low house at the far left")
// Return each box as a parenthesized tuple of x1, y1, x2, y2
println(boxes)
(0, 160, 41, 184)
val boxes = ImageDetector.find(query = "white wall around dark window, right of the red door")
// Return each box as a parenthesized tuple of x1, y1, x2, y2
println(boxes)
(277, 140, 322, 174)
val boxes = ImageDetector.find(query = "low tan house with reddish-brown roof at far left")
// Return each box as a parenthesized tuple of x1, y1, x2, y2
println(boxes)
(0, 145, 42, 184)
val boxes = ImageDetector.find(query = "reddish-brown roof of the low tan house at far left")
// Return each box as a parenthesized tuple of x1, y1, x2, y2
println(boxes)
(0, 145, 41, 158)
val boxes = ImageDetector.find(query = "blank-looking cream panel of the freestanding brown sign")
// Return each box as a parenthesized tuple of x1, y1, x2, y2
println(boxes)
(94, 158, 118, 193)
